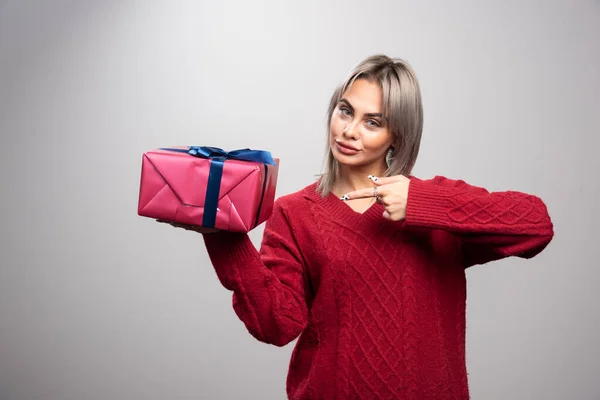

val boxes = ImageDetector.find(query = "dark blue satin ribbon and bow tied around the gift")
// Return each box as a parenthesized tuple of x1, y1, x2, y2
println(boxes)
(161, 146, 277, 228)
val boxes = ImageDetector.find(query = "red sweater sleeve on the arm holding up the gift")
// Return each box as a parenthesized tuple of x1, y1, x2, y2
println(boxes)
(204, 202, 308, 346)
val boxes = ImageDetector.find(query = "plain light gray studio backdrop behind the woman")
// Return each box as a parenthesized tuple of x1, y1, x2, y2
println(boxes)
(0, 0, 600, 400)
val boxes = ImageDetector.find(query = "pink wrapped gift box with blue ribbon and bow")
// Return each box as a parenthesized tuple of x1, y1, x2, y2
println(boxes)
(138, 146, 279, 232)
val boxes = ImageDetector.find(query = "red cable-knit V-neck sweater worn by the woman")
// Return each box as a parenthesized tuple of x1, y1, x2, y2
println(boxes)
(204, 177, 553, 400)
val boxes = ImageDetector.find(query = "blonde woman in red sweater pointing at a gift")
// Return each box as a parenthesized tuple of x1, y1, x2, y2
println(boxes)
(165, 56, 553, 400)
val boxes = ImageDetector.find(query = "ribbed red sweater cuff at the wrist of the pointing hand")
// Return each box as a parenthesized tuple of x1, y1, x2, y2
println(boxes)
(405, 179, 454, 229)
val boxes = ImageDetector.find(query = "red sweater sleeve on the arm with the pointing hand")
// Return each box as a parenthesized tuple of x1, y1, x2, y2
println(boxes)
(405, 176, 554, 268)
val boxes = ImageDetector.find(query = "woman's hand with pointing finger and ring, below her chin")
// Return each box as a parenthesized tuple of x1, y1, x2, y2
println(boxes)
(341, 175, 410, 221)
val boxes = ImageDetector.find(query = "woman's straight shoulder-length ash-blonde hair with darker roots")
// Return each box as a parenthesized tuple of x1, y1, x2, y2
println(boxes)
(317, 55, 423, 197)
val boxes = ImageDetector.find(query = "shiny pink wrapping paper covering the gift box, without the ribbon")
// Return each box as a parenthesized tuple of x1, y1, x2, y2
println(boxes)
(138, 149, 279, 232)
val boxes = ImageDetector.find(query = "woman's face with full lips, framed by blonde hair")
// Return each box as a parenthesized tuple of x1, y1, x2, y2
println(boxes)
(329, 79, 394, 169)
